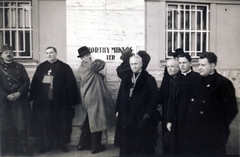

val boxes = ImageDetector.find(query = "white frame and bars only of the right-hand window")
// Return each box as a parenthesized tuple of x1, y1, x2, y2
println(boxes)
(165, 2, 210, 58)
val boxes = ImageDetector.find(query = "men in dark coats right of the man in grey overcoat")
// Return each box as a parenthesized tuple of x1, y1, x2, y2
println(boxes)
(114, 48, 238, 157)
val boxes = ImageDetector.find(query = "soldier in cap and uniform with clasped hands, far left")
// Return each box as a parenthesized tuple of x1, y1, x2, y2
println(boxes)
(0, 45, 30, 155)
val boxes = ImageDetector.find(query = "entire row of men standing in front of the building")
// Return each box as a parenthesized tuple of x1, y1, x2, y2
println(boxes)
(0, 45, 238, 157)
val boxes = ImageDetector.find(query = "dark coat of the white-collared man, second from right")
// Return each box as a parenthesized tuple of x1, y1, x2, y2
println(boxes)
(166, 71, 200, 154)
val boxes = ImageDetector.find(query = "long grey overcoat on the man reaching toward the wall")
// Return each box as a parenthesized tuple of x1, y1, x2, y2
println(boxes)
(78, 60, 116, 132)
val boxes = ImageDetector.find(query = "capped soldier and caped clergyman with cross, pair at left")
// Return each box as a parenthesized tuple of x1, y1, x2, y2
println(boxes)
(0, 44, 80, 156)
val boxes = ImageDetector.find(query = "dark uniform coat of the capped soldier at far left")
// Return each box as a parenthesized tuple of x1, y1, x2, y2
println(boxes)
(0, 61, 30, 131)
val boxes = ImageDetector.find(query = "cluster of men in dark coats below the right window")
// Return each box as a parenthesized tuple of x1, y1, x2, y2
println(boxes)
(159, 48, 238, 156)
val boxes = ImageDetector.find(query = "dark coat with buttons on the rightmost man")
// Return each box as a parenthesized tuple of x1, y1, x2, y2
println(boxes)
(184, 71, 238, 155)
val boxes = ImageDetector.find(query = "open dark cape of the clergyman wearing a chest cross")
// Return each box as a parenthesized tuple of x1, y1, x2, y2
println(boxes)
(30, 60, 80, 142)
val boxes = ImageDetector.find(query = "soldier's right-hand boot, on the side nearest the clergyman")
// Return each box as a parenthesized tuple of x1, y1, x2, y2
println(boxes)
(18, 130, 30, 156)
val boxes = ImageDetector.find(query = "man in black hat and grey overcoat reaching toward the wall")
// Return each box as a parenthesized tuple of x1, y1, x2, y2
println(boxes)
(77, 46, 116, 154)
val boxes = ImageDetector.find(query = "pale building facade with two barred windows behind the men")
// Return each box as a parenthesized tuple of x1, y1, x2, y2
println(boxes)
(0, 0, 240, 154)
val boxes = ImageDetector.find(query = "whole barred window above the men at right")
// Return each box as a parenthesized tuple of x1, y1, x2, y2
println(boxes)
(166, 3, 210, 58)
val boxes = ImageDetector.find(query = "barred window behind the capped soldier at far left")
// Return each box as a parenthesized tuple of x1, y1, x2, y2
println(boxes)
(0, 1, 32, 58)
